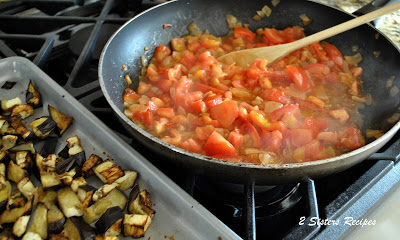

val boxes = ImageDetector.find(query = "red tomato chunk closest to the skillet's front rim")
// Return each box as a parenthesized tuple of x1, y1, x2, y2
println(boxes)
(203, 131, 237, 156)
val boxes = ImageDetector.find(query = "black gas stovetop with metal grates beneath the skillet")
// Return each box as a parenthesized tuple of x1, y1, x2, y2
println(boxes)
(0, 0, 400, 239)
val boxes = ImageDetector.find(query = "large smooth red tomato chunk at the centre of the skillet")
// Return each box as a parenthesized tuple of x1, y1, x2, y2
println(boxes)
(210, 100, 239, 128)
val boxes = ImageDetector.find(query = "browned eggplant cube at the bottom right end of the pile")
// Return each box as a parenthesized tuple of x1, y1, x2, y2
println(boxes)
(123, 214, 151, 238)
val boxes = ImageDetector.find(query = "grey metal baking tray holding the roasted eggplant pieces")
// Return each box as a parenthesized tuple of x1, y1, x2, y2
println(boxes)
(0, 57, 241, 240)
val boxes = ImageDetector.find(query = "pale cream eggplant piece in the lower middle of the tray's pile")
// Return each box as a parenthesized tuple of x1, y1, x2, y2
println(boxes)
(57, 186, 83, 218)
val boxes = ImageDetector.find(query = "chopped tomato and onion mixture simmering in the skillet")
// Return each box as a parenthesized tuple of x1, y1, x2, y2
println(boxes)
(124, 26, 365, 164)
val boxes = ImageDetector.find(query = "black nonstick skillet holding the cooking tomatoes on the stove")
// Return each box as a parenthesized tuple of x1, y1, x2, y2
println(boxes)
(99, 0, 400, 184)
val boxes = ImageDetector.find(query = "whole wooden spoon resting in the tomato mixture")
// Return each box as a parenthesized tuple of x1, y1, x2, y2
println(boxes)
(218, 2, 400, 68)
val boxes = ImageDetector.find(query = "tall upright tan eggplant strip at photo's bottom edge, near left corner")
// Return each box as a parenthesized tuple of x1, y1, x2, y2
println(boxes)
(26, 203, 47, 239)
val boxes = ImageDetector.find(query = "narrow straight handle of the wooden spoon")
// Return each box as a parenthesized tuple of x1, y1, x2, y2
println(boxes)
(288, 2, 400, 52)
